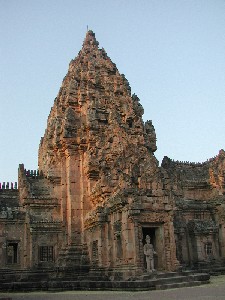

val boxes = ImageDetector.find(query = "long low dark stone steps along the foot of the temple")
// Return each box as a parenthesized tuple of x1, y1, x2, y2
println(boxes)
(0, 271, 210, 291)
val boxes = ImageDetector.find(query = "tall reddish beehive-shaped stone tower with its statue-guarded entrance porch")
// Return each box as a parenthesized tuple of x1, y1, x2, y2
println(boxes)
(17, 31, 176, 277)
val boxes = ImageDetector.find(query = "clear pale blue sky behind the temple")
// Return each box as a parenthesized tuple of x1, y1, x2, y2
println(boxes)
(0, 0, 225, 182)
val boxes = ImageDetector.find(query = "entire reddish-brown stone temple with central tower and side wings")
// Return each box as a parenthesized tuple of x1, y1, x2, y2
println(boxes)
(0, 31, 225, 288)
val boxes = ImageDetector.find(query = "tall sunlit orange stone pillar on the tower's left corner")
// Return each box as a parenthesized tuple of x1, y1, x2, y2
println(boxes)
(58, 146, 89, 274)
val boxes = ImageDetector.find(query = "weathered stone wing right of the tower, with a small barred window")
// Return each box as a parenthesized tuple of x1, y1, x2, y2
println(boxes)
(162, 150, 225, 267)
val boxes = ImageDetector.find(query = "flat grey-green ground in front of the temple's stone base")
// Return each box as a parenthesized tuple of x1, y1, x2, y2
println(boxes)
(0, 275, 225, 300)
